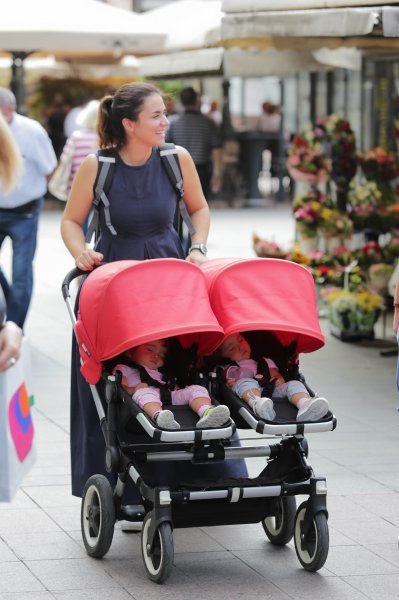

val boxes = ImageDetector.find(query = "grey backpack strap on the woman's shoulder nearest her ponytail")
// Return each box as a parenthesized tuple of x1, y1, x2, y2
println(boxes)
(85, 148, 117, 243)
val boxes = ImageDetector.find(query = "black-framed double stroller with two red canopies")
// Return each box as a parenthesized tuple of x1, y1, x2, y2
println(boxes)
(62, 258, 336, 583)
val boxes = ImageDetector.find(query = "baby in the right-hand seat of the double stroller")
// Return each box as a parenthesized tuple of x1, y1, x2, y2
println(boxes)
(217, 333, 329, 421)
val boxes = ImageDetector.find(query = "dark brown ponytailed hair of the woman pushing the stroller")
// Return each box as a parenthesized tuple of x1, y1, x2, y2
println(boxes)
(97, 82, 162, 148)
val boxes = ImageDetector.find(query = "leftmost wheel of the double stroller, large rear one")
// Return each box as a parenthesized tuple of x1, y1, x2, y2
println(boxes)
(81, 475, 115, 558)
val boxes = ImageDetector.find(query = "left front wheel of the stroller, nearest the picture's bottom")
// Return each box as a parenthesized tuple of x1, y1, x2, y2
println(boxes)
(141, 512, 174, 583)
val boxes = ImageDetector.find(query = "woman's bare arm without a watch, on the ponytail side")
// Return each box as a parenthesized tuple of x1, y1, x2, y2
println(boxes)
(61, 154, 103, 271)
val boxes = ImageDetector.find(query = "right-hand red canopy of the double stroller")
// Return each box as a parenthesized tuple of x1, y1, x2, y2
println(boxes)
(201, 258, 324, 353)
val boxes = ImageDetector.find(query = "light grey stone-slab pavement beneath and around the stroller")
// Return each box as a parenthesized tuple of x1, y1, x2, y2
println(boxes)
(0, 204, 399, 600)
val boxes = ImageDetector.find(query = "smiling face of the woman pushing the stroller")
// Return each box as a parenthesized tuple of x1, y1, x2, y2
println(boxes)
(124, 94, 169, 147)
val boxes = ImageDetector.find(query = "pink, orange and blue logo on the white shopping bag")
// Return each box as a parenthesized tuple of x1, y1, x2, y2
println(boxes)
(8, 383, 33, 462)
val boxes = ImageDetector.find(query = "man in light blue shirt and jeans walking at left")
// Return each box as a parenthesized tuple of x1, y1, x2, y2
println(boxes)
(0, 87, 57, 328)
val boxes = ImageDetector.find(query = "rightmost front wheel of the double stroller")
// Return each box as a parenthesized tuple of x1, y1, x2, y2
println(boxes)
(294, 502, 329, 571)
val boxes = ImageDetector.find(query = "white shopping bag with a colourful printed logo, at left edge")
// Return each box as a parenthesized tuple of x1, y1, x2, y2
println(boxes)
(0, 339, 36, 502)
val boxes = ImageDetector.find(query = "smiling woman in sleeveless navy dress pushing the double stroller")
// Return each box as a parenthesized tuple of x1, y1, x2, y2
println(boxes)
(61, 83, 246, 503)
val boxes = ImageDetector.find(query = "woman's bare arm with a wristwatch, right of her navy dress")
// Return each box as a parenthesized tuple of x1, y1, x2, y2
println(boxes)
(177, 146, 210, 264)
